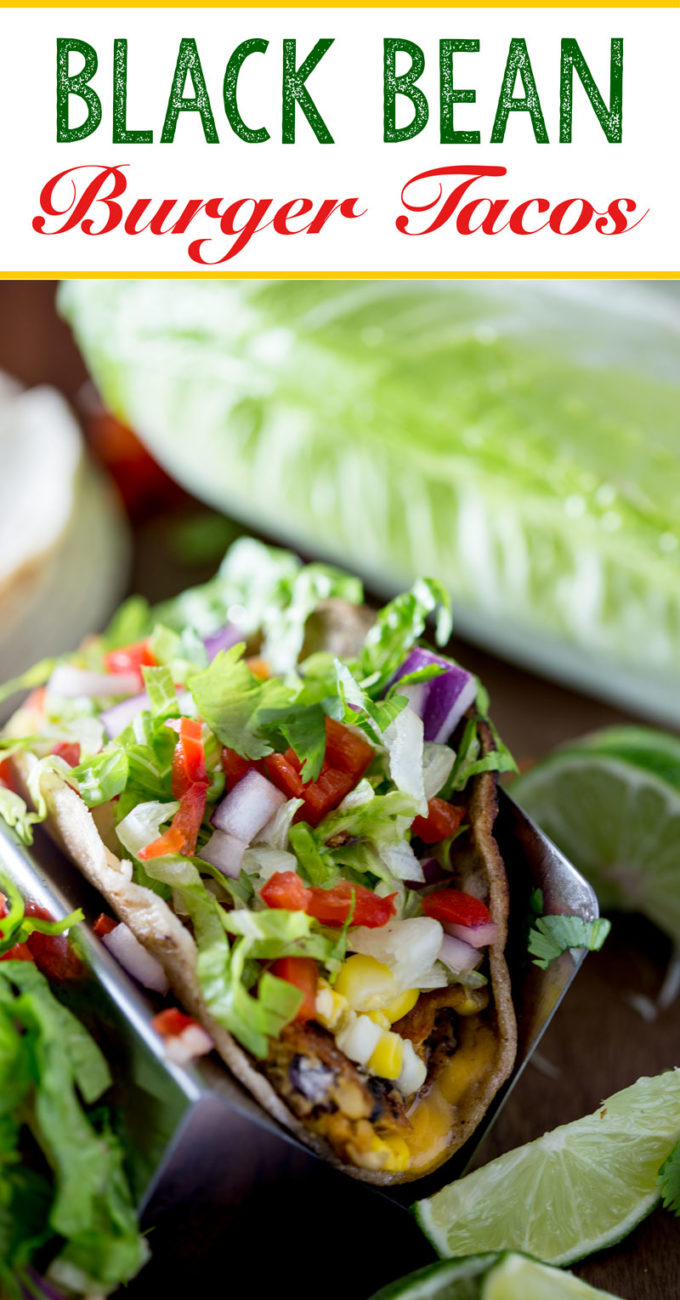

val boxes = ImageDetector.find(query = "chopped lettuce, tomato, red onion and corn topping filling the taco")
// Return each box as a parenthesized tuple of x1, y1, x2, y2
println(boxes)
(0, 542, 507, 1102)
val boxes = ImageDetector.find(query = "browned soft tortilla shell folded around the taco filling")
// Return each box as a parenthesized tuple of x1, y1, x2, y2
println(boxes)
(7, 603, 516, 1186)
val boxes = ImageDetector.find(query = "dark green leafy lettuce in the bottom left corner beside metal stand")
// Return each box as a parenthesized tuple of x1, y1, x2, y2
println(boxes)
(0, 878, 148, 1300)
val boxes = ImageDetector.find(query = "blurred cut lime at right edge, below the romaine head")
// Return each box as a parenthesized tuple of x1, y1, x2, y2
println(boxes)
(510, 727, 680, 943)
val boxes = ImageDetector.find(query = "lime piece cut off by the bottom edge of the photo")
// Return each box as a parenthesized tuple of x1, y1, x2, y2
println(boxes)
(373, 1252, 615, 1300)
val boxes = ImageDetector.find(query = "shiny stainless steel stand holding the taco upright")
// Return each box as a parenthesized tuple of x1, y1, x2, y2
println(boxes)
(0, 793, 598, 1300)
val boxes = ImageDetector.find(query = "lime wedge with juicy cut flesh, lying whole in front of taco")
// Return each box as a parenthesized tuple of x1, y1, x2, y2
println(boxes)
(415, 1070, 680, 1264)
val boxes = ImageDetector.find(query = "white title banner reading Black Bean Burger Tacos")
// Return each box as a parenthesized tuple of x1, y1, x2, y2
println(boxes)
(0, 8, 680, 276)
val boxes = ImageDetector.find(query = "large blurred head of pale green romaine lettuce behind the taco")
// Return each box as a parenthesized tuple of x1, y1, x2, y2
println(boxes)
(60, 281, 680, 723)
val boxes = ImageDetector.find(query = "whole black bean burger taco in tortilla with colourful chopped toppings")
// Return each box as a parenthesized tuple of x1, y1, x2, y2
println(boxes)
(0, 540, 516, 1183)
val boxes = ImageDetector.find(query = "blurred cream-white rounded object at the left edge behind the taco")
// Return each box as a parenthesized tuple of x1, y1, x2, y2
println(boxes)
(0, 374, 130, 716)
